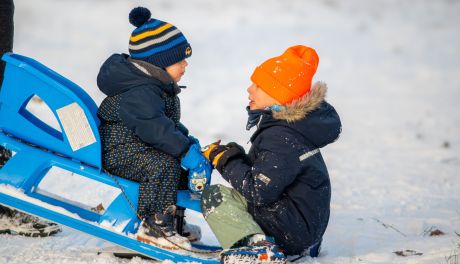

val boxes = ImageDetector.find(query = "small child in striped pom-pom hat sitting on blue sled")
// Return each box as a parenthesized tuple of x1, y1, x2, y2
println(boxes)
(97, 7, 211, 249)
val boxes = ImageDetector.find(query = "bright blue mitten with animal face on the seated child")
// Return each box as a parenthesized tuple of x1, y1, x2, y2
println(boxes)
(181, 143, 212, 192)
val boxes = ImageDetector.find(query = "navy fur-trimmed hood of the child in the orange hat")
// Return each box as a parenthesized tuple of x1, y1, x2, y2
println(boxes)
(251, 82, 342, 148)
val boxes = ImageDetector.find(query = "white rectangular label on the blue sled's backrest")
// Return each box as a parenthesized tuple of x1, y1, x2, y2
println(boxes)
(56, 103, 96, 151)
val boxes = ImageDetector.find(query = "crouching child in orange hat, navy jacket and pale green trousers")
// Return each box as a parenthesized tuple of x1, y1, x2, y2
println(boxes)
(201, 45, 341, 263)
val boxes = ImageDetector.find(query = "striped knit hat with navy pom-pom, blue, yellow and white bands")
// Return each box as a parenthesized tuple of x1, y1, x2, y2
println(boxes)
(129, 7, 192, 68)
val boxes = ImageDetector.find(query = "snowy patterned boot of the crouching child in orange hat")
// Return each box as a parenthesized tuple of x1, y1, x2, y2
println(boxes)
(220, 235, 287, 264)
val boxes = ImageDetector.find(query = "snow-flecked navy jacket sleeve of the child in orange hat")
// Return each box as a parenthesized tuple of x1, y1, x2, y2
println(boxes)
(218, 131, 300, 206)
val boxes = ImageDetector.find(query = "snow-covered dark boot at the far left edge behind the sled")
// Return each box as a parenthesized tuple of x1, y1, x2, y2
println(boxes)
(0, 206, 61, 237)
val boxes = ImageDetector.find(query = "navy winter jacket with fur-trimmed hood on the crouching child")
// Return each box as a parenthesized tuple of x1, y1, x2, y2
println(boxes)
(217, 83, 341, 255)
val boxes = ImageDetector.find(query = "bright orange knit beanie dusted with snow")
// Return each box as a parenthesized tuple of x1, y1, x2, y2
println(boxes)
(251, 45, 319, 105)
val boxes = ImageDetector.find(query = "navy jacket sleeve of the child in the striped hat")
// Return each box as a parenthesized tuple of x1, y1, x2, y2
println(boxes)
(120, 87, 189, 157)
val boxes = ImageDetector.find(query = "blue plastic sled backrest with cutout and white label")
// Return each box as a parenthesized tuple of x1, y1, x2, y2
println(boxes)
(0, 53, 101, 169)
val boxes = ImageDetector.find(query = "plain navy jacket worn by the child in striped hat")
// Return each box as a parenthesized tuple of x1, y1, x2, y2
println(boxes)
(97, 54, 190, 158)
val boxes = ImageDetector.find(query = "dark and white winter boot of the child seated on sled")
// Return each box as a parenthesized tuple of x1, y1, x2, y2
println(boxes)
(137, 205, 191, 250)
